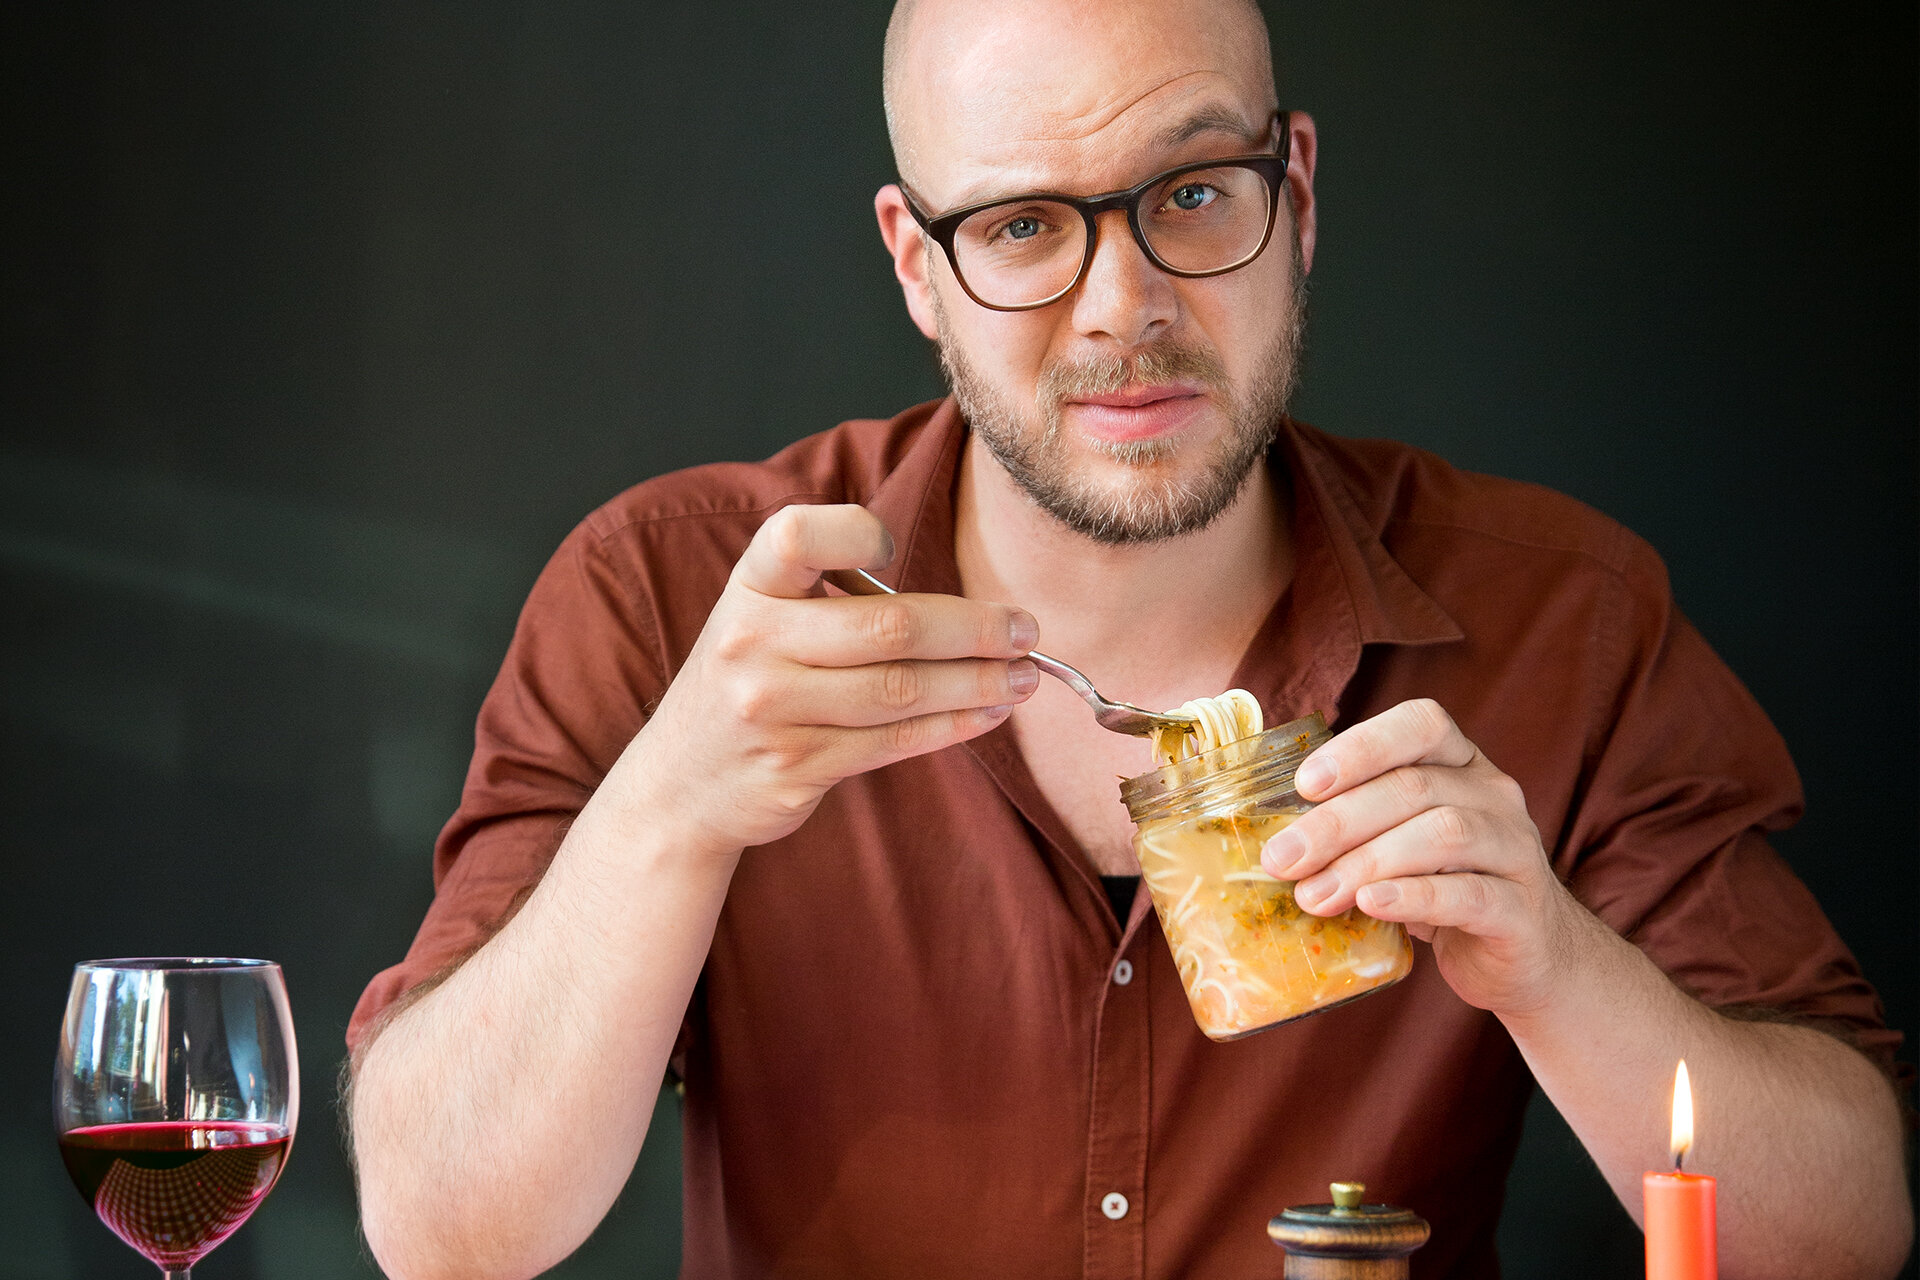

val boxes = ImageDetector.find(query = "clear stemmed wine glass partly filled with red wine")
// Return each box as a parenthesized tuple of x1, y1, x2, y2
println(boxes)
(54, 960, 300, 1280)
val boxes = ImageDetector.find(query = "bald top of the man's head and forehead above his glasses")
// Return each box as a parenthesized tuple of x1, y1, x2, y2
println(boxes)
(883, 0, 1275, 205)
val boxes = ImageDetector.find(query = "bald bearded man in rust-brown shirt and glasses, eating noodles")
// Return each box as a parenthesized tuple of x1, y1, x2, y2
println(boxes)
(351, 0, 1910, 1280)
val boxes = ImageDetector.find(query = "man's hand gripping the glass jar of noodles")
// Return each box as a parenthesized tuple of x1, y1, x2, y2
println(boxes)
(1261, 699, 1597, 1015)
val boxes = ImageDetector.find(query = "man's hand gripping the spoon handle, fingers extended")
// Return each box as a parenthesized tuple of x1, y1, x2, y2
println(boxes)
(609, 507, 1041, 856)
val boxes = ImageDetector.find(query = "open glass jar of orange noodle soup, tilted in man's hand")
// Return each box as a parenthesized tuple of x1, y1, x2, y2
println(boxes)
(1119, 712, 1413, 1040)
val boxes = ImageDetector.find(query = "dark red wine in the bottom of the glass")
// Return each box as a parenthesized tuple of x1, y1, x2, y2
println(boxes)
(60, 1121, 292, 1270)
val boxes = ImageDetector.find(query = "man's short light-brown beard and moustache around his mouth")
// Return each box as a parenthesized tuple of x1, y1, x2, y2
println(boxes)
(933, 242, 1306, 547)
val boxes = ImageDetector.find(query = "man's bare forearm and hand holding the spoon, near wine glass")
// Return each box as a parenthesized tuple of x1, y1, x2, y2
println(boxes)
(351, 505, 1039, 1280)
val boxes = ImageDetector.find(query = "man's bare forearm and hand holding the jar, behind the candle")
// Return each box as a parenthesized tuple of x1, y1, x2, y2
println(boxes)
(1263, 699, 1912, 1280)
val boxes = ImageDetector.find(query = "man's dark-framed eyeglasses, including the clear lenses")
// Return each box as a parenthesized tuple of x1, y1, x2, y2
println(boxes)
(902, 111, 1292, 311)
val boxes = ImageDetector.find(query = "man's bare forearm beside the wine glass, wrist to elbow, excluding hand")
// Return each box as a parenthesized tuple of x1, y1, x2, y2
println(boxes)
(351, 748, 737, 1280)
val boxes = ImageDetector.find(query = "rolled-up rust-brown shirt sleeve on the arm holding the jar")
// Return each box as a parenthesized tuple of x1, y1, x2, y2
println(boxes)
(1559, 539, 1901, 1073)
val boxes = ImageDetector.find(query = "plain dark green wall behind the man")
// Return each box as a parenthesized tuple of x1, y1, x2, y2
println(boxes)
(0, 0, 1920, 1280)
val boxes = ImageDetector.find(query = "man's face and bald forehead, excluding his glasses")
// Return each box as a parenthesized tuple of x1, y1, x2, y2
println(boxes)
(883, 0, 1311, 543)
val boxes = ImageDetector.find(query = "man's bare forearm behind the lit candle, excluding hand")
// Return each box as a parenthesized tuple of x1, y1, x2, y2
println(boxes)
(1501, 912, 1912, 1280)
